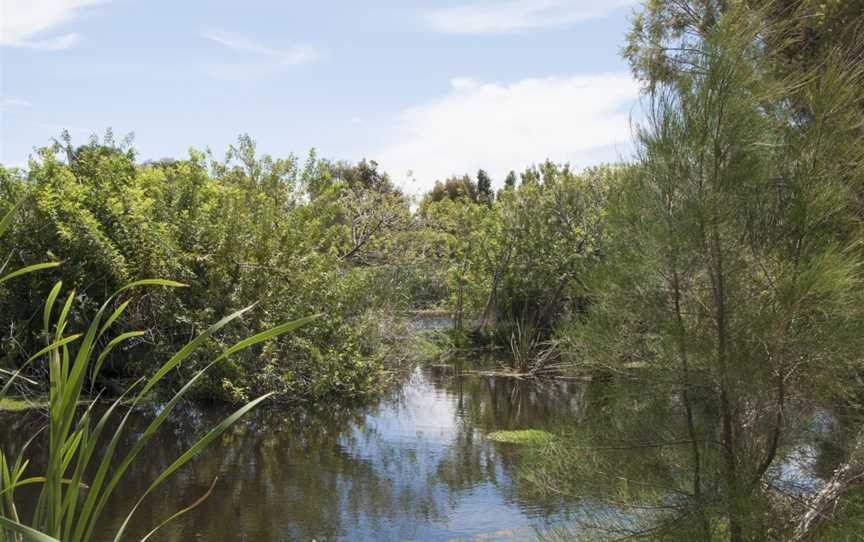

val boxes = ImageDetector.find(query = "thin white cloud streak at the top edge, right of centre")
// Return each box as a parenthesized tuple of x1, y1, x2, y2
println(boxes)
(424, 0, 637, 34)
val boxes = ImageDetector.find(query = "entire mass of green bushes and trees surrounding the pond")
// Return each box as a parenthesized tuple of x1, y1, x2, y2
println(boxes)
(0, 0, 864, 542)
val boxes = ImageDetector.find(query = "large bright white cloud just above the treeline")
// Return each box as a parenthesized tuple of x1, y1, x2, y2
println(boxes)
(373, 73, 639, 192)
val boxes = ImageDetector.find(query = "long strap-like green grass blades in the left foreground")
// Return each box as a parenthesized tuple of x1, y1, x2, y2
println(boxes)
(0, 205, 314, 542)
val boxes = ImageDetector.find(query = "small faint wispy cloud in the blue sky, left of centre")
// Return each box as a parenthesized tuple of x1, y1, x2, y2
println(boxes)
(201, 30, 323, 78)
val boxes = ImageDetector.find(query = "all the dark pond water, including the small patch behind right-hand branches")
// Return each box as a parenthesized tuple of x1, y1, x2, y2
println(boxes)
(0, 367, 848, 542)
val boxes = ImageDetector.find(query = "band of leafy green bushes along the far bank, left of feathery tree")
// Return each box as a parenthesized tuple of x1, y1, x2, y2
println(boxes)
(0, 127, 618, 401)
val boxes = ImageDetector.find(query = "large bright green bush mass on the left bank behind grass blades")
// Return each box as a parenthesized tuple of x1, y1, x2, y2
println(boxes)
(0, 138, 409, 401)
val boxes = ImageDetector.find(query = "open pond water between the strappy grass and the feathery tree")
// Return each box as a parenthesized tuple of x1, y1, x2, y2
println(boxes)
(0, 368, 584, 542)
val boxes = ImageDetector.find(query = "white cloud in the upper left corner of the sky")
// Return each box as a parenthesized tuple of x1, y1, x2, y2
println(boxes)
(0, 0, 108, 51)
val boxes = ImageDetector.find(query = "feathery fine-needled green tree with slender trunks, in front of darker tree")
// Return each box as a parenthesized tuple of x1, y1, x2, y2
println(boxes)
(544, 10, 864, 542)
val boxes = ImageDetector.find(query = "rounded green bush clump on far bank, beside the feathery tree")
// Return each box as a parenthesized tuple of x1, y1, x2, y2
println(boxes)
(418, 162, 617, 371)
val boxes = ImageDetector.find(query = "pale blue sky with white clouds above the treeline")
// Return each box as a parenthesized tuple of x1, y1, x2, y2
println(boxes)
(0, 0, 639, 193)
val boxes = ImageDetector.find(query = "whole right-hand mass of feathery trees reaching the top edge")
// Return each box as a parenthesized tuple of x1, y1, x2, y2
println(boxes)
(536, 2, 864, 542)
